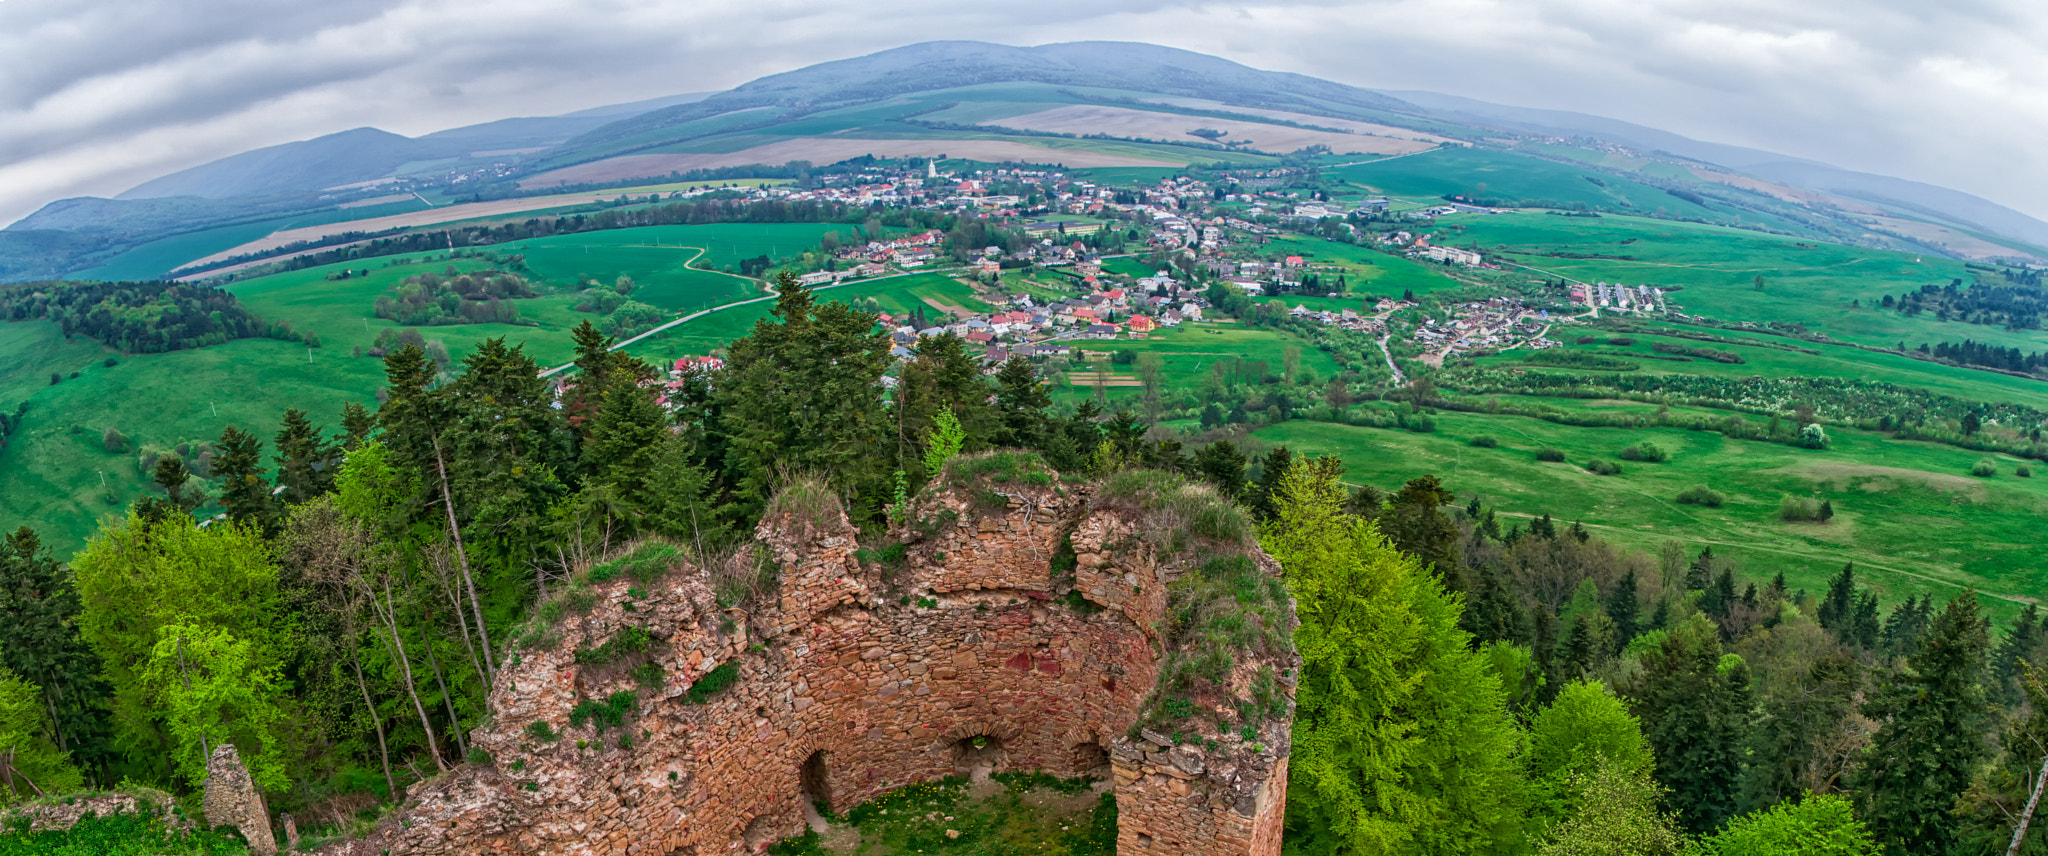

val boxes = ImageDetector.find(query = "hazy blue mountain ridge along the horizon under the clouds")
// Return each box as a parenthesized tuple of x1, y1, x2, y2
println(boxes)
(0, 41, 2048, 283)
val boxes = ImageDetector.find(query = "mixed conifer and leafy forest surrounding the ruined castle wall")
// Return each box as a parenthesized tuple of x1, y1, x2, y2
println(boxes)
(0, 276, 2048, 854)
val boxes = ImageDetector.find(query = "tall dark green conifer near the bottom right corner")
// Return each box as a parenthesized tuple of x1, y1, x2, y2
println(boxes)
(1853, 590, 1991, 854)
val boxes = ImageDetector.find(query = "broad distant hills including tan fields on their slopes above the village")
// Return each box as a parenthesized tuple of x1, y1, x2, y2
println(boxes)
(12, 41, 2048, 281)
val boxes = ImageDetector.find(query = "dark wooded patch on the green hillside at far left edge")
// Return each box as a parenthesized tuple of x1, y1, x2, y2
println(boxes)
(0, 283, 305, 354)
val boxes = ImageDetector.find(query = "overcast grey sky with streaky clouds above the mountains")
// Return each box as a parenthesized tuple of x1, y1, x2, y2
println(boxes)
(0, 0, 2048, 223)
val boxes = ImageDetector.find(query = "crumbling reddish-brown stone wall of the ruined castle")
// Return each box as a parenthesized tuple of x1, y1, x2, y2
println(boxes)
(330, 475, 1290, 856)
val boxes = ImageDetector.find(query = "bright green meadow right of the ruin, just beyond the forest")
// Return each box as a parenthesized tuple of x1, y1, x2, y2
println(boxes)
(1255, 401, 2048, 618)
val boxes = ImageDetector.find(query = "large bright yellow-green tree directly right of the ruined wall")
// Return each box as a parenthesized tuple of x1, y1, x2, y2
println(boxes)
(1260, 461, 1526, 854)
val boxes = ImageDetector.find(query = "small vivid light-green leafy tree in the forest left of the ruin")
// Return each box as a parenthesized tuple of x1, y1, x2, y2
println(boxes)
(143, 625, 291, 790)
